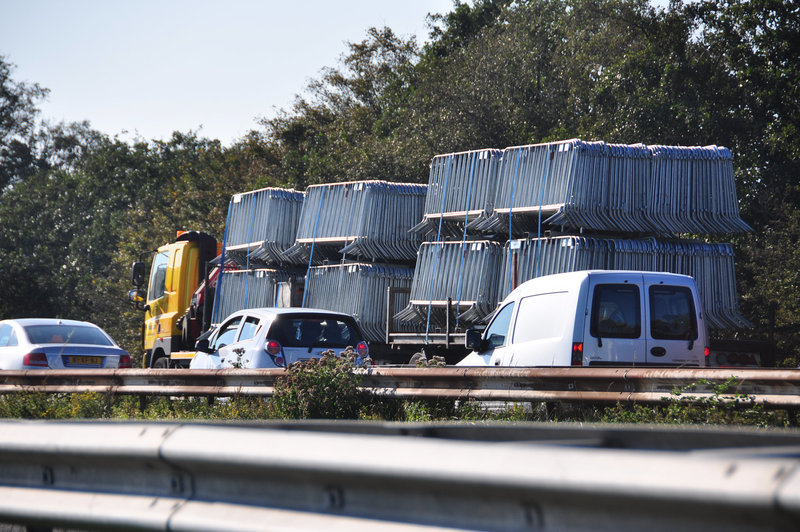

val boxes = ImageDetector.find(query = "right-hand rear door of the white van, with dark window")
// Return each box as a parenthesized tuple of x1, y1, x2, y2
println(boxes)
(644, 273, 705, 365)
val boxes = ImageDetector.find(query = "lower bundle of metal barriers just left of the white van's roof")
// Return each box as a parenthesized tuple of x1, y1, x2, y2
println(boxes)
(395, 240, 503, 327)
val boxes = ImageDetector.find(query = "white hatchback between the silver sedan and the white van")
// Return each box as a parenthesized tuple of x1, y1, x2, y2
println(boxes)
(189, 308, 369, 369)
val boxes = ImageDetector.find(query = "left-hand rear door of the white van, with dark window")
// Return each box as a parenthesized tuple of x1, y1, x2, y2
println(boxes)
(583, 272, 647, 365)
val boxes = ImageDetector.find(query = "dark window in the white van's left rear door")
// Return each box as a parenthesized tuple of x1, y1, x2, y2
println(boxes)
(590, 284, 642, 338)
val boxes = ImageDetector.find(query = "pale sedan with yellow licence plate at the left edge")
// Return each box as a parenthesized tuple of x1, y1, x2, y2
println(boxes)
(0, 318, 131, 370)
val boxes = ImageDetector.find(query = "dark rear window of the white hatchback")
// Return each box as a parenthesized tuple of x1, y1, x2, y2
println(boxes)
(269, 316, 362, 347)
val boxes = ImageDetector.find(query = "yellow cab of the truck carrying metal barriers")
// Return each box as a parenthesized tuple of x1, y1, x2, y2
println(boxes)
(129, 231, 218, 368)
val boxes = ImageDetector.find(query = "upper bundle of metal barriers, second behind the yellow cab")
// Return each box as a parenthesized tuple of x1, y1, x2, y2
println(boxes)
(285, 181, 427, 264)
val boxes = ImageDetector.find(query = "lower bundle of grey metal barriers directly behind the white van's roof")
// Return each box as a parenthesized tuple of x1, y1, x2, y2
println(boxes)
(499, 236, 749, 329)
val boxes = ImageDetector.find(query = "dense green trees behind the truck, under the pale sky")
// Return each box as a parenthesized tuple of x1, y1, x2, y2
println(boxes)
(0, 0, 800, 362)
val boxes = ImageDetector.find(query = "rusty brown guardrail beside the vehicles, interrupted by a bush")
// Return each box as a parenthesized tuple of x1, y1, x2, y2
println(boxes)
(0, 366, 800, 410)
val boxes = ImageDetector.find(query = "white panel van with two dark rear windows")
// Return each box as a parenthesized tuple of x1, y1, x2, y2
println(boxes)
(458, 270, 708, 366)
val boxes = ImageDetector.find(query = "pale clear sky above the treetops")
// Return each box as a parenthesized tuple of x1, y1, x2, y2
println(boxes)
(0, 0, 453, 145)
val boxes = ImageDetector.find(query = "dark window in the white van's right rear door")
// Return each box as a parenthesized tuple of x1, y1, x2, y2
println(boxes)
(649, 285, 697, 340)
